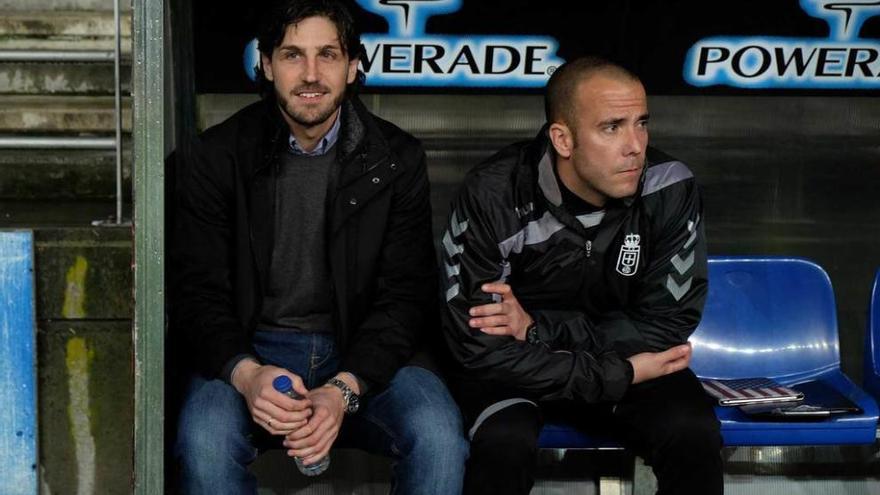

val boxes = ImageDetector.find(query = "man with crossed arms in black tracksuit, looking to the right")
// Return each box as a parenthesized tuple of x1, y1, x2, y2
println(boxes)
(443, 57, 722, 495)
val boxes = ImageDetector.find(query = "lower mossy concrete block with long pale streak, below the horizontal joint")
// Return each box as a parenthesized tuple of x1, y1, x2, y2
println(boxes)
(37, 320, 134, 495)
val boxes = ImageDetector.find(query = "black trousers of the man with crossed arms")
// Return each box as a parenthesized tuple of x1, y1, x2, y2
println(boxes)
(458, 370, 724, 495)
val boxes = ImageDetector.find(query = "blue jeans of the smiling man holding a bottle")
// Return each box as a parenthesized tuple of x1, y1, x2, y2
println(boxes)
(174, 332, 468, 495)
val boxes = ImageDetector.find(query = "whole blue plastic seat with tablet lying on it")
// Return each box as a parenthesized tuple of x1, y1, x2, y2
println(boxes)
(691, 257, 878, 446)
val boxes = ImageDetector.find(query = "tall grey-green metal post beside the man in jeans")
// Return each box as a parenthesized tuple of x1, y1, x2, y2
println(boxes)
(132, 0, 165, 495)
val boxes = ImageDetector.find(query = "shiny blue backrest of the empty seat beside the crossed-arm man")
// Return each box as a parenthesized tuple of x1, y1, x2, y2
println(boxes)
(690, 256, 840, 384)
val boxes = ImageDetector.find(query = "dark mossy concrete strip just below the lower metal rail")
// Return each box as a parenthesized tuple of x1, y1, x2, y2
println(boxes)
(0, 145, 131, 200)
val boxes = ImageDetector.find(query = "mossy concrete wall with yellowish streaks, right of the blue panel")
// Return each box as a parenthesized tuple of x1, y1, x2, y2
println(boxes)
(35, 228, 134, 495)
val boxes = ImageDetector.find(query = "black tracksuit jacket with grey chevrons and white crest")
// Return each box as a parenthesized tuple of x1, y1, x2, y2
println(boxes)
(441, 130, 708, 402)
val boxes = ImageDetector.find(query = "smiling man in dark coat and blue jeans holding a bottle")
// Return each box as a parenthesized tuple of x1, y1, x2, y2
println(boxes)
(170, 0, 467, 495)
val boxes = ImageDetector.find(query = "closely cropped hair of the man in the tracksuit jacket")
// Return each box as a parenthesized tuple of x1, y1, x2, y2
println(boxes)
(544, 55, 641, 127)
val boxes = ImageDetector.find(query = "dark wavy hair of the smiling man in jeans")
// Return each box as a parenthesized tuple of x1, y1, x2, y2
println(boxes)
(256, 0, 364, 95)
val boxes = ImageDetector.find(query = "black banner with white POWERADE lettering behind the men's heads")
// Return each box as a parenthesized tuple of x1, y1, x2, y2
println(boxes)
(193, 0, 880, 95)
